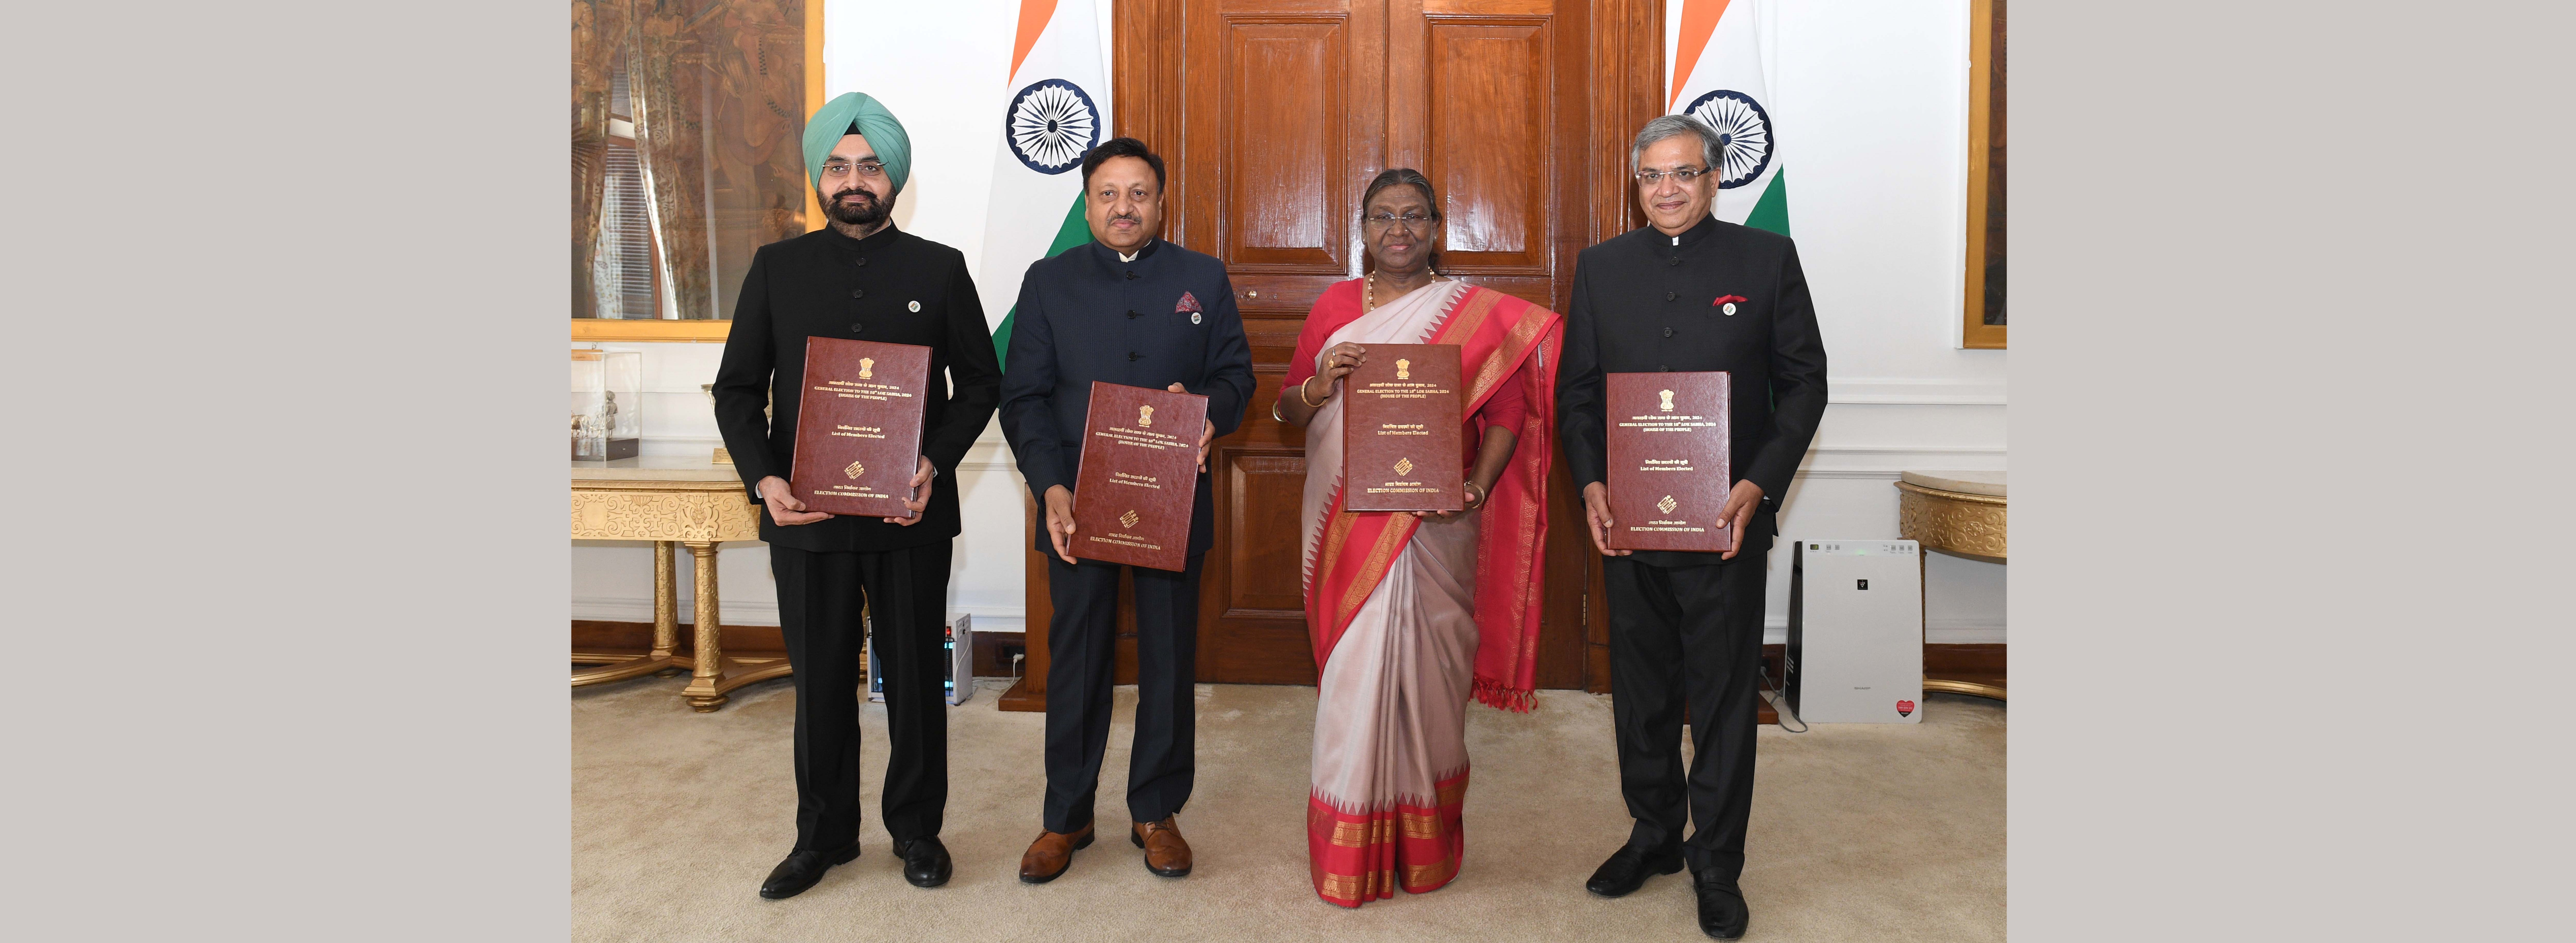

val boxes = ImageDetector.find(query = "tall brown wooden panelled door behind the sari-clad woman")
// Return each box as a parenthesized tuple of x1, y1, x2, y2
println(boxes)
(1028, 0, 1662, 696)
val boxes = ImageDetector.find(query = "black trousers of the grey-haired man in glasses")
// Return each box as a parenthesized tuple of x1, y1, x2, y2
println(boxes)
(1602, 513, 1772, 881)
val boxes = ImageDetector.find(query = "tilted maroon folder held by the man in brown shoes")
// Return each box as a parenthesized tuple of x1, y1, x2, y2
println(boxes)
(1072, 384, 1208, 572)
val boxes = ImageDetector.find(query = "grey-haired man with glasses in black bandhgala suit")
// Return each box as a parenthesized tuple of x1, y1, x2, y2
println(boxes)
(1556, 116, 1824, 940)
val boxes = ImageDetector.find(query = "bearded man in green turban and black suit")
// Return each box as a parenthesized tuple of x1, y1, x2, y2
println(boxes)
(716, 93, 1002, 899)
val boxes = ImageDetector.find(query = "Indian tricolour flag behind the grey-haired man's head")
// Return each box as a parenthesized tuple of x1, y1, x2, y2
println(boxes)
(1664, 0, 1788, 234)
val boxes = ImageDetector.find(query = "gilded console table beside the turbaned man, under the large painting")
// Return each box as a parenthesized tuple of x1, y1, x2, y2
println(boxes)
(572, 456, 788, 714)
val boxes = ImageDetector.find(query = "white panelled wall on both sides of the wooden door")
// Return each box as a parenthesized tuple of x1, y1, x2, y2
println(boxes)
(572, 0, 2004, 641)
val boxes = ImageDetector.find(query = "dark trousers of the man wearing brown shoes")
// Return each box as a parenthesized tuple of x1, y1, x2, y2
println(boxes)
(1046, 554, 1206, 835)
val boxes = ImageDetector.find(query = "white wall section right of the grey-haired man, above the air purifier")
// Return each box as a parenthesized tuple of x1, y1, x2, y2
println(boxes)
(1762, 0, 2007, 641)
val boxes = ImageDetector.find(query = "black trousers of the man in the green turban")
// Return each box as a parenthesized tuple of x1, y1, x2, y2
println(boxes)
(770, 541, 951, 850)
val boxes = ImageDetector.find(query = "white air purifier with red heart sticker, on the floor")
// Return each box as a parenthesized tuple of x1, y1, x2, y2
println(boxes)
(1785, 539, 1924, 724)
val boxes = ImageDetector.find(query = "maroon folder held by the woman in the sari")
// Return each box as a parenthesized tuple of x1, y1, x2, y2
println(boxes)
(1342, 343, 1466, 510)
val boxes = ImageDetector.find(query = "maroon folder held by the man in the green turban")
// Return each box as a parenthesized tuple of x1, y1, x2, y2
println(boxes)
(788, 338, 930, 518)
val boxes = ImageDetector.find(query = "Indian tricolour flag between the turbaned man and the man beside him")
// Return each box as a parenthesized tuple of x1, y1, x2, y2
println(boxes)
(976, 0, 1110, 358)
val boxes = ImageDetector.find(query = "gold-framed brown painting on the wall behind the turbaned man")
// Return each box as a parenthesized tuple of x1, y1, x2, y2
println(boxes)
(569, 0, 822, 343)
